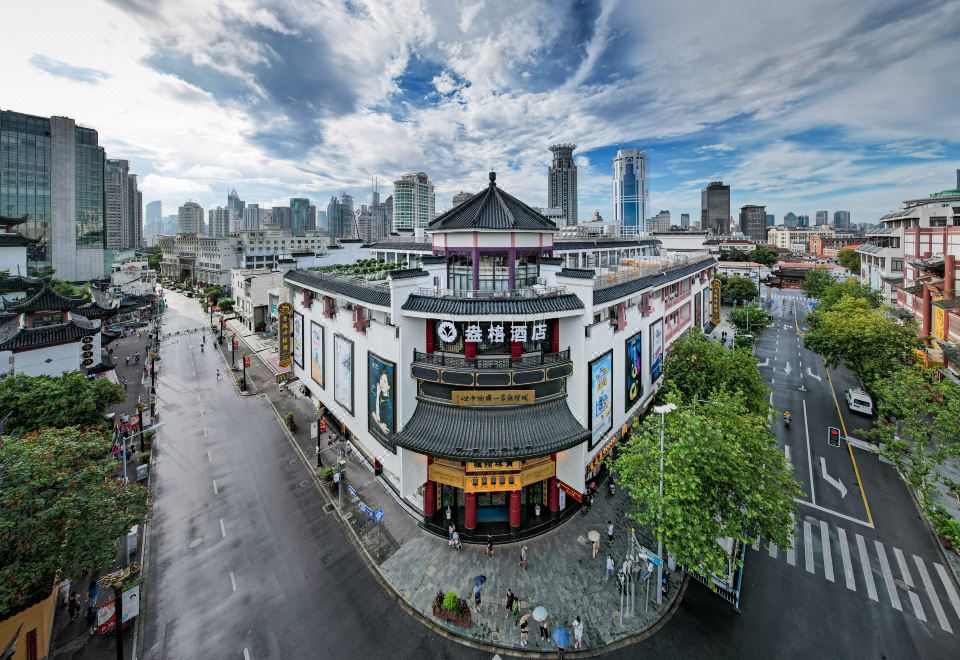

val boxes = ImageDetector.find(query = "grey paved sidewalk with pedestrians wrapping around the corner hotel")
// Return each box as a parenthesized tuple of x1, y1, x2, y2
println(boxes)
(222, 324, 682, 655)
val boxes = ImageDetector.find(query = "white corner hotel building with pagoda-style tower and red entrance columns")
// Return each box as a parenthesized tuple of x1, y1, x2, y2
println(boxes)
(280, 173, 716, 540)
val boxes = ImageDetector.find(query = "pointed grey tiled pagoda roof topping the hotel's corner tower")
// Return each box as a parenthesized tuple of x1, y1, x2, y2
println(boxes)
(428, 172, 557, 231)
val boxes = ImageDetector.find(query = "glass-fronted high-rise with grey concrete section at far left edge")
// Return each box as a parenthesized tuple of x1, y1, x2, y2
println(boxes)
(0, 110, 106, 282)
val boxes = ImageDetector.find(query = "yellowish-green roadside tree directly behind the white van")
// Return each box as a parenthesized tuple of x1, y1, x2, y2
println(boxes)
(803, 296, 920, 384)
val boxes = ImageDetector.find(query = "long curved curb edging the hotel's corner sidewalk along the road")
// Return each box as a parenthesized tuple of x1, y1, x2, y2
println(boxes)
(258, 394, 690, 658)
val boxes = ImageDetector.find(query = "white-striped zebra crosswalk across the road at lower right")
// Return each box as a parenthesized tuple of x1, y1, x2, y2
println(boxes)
(752, 516, 960, 634)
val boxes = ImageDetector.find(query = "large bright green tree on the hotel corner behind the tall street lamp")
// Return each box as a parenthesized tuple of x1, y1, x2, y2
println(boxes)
(612, 393, 802, 575)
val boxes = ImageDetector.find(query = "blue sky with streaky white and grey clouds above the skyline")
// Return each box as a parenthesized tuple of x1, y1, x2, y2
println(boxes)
(0, 0, 960, 223)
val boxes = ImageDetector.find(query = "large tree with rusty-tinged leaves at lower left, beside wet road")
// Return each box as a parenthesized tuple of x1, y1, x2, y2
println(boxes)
(0, 428, 148, 611)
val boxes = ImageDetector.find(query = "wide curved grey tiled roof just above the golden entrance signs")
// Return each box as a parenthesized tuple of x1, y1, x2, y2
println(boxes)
(394, 399, 590, 460)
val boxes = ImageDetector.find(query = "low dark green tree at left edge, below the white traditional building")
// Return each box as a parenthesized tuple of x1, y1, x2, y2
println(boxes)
(0, 371, 125, 433)
